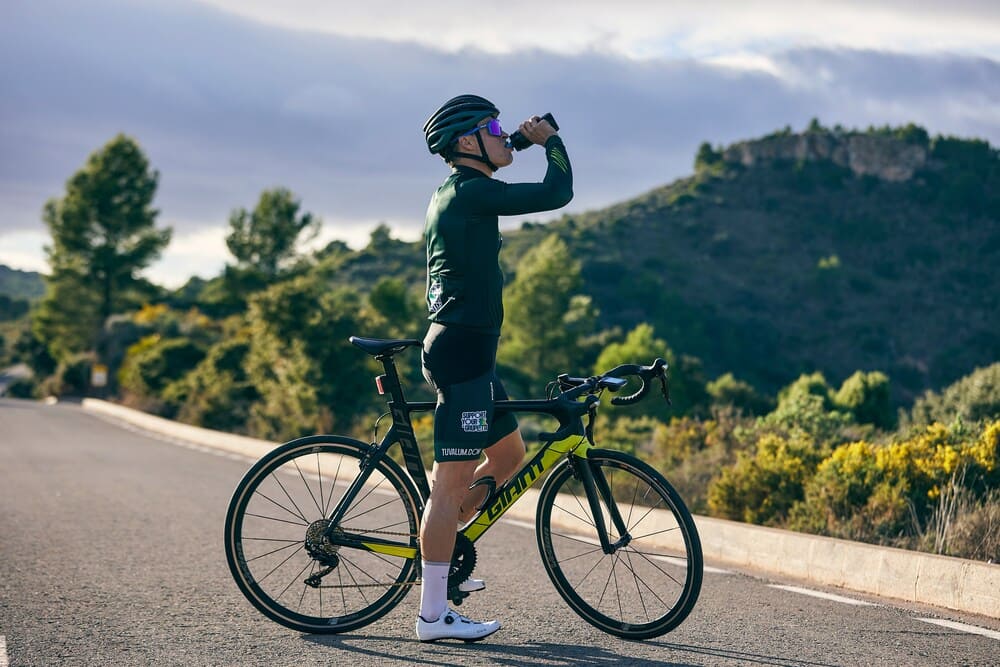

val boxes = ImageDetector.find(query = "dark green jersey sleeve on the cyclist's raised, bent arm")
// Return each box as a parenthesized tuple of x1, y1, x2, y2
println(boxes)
(458, 135, 573, 215)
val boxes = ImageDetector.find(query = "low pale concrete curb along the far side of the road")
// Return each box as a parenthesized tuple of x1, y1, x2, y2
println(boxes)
(83, 398, 1000, 618)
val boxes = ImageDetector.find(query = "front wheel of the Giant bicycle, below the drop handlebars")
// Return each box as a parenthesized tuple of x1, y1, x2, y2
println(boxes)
(536, 450, 704, 639)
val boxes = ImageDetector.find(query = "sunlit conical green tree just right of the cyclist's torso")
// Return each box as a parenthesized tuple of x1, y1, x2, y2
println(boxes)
(498, 234, 597, 388)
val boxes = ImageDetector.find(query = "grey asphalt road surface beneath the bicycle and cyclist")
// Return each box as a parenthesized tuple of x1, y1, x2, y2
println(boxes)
(0, 399, 1000, 667)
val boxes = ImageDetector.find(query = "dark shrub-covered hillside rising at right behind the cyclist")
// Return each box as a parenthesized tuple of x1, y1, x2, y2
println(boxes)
(505, 126, 1000, 402)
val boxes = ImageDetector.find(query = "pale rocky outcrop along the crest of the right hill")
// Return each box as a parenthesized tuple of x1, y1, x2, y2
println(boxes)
(722, 132, 929, 181)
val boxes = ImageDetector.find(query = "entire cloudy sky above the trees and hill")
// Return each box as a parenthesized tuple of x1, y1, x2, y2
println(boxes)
(0, 0, 1000, 287)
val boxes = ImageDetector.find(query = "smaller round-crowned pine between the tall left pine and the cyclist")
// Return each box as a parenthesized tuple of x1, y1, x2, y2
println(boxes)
(226, 188, 321, 278)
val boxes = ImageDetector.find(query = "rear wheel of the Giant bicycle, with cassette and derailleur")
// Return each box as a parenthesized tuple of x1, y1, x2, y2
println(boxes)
(225, 435, 421, 634)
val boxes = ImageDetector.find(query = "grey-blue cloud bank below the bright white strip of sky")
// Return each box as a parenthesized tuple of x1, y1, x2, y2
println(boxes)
(0, 0, 1000, 282)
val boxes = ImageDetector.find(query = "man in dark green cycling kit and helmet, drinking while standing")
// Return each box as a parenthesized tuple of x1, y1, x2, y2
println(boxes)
(416, 95, 573, 641)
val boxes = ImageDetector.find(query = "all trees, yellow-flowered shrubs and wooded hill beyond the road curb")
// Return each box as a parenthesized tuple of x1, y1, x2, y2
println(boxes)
(0, 121, 1000, 562)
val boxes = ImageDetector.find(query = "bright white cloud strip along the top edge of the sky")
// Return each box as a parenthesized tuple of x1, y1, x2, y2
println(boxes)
(195, 0, 1000, 58)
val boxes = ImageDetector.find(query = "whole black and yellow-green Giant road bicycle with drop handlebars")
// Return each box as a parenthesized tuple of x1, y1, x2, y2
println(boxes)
(225, 337, 703, 639)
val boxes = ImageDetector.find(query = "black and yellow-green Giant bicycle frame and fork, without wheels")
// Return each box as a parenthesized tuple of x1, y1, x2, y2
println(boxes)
(326, 354, 629, 558)
